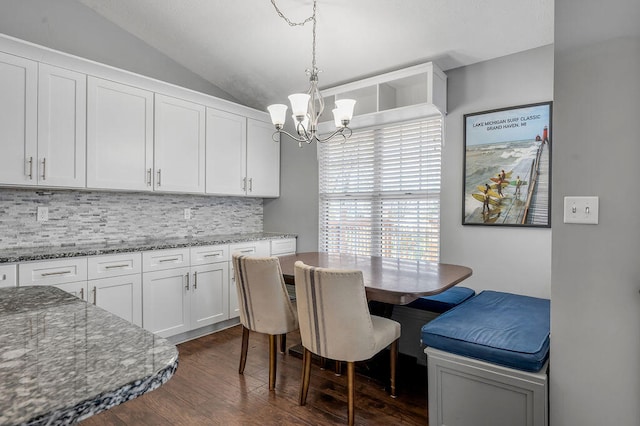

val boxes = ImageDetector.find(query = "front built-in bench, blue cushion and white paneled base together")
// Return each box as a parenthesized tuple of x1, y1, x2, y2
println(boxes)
(421, 291, 550, 426)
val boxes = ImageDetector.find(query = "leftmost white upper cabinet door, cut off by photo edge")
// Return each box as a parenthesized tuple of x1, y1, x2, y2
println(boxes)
(0, 53, 38, 185)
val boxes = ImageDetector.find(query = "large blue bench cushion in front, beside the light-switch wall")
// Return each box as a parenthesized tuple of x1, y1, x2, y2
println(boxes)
(422, 291, 551, 371)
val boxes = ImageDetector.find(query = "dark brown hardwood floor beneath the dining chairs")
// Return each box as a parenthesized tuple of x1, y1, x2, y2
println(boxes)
(82, 326, 427, 426)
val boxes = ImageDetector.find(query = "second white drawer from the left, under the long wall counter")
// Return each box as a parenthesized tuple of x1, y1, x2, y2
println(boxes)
(18, 257, 87, 285)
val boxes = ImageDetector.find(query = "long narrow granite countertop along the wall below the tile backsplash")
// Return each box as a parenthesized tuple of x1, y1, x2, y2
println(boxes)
(0, 232, 296, 264)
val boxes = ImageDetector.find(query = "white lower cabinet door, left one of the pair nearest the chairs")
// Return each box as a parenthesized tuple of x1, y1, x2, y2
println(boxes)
(142, 267, 192, 337)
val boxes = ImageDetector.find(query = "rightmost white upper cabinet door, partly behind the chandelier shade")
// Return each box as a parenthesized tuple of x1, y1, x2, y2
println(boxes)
(247, 118, 280, 197)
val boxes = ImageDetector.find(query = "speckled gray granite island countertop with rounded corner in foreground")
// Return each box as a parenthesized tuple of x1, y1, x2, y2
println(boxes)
(0, 286, 178, 425)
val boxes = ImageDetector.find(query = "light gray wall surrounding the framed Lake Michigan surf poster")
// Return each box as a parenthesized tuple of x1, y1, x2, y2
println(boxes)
(440, 46, 555, 298)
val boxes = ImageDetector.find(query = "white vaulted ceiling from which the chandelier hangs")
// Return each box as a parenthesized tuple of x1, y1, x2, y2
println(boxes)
(78, 0, 554, 109)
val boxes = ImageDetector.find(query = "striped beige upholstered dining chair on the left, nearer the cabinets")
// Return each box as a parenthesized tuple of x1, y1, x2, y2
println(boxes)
(233, 254, 298, 390)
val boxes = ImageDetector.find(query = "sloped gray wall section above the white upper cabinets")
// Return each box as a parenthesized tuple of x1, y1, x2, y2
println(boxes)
(0, 0, 236, 102)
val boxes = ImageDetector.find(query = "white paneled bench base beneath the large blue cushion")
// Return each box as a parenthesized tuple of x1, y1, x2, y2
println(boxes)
(424, 347, 549, 426)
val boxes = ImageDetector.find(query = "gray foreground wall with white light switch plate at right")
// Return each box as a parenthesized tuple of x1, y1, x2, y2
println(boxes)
(550, 0, 640, 426)
